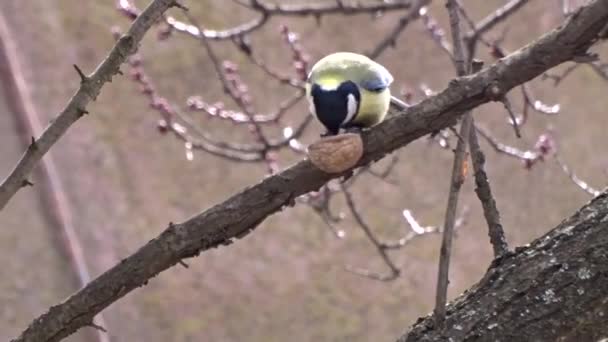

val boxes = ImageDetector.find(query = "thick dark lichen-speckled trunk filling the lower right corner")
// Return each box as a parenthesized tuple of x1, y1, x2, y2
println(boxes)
(399, 191, 608, 342)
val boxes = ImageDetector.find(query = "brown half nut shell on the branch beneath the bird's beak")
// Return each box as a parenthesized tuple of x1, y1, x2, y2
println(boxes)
(308, 133, 363, 173)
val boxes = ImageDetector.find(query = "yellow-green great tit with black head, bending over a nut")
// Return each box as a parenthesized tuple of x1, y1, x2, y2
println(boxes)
(306, 52, 393, 135)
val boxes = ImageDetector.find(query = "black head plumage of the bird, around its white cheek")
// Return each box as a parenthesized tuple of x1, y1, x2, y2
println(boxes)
(310, 81, 361, 134)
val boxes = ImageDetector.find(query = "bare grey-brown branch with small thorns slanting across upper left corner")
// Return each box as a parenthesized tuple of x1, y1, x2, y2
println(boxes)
(0, 0, 176, 210)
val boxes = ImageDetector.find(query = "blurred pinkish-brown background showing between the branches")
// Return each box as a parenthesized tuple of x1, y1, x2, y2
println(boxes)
(0, 0, 608, 341)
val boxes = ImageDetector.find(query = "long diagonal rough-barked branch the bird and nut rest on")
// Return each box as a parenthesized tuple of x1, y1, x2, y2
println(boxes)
(14, 0, 608, 341)
